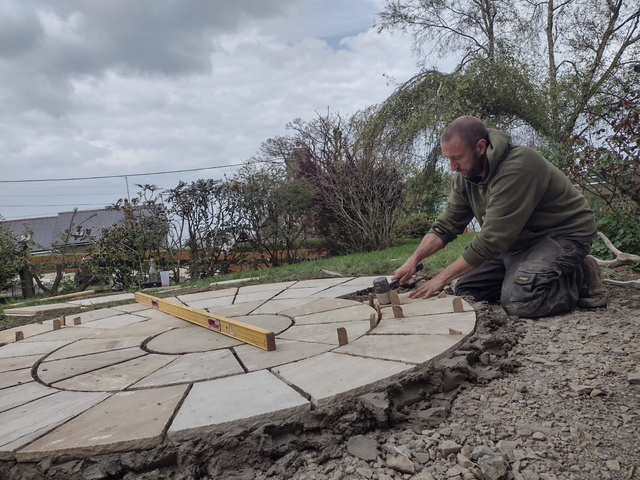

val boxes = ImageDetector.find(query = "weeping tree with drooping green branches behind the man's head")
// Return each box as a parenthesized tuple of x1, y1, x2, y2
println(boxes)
(361, 47, 546, 234)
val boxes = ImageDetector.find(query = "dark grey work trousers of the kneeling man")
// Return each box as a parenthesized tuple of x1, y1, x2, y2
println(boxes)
(455, 236, 593, 318)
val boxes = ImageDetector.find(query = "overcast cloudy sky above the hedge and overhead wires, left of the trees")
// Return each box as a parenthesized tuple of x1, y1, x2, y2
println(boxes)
(0, 0, 417, 220)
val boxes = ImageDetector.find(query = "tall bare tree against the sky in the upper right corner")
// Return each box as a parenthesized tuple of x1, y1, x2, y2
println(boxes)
(379, 0, 640, 138)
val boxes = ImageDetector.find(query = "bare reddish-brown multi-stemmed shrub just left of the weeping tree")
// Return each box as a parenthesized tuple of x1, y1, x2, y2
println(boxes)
(288, 112, 405, 252)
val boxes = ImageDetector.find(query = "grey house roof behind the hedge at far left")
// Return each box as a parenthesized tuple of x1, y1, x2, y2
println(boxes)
(2, 207, 155, 253)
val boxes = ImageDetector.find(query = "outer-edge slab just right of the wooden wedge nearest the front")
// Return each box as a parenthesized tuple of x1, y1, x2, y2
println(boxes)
(334, 335, 467, 364)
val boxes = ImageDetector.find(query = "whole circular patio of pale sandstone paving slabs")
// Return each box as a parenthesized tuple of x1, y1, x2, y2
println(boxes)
(0, 276, 475, 461)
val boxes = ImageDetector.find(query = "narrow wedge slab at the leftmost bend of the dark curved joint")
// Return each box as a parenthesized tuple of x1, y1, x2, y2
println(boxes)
(36, 347, 148, 385)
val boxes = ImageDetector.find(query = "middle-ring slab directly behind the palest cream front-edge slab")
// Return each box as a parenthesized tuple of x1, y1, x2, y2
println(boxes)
(131, 350, 244, 389)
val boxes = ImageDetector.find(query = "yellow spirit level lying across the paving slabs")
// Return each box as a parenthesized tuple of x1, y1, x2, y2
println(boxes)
(136, 292, 276, 350)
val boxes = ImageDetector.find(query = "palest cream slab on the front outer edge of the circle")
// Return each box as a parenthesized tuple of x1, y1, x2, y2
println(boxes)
(168, 370, 311, 441)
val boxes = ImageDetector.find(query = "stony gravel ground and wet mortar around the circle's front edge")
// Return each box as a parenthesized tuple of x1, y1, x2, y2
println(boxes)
(0, 271, 640, 480)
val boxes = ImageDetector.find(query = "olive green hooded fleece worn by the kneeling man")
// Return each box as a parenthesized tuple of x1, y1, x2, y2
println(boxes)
(430, 129, 596, 267)
